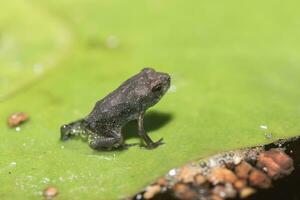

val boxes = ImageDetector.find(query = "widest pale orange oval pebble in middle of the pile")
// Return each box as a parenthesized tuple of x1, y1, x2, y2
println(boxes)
(209, 168, 237, 185)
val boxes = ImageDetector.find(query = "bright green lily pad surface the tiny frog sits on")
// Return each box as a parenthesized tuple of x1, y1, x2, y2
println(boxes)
(0, 0, 300, 200)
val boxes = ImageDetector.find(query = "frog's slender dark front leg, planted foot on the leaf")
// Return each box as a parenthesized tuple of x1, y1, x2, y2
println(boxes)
(138, 112, 164, 149)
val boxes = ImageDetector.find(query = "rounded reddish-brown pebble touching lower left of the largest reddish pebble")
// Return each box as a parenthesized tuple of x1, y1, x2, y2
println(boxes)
(249, 169, 271, 189)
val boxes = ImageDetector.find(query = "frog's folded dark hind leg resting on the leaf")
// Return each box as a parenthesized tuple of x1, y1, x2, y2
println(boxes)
(88, 131, 123, 151)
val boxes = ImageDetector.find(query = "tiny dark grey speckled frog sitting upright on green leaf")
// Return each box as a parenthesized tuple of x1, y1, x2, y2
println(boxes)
(61, 68, 171, 150)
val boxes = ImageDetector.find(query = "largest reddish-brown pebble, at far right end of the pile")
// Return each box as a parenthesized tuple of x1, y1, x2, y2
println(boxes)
(257, 149, 294, 179)
